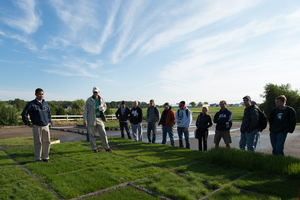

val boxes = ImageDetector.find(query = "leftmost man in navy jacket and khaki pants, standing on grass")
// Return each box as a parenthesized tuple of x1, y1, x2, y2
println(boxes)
(22, 88, 52, 162)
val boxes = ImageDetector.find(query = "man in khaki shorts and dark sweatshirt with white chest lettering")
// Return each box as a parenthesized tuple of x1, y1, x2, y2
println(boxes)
(214, 100, 232, 148)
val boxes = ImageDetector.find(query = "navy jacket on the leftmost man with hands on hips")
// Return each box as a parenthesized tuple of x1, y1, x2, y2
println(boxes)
(21, 99, 52, 126)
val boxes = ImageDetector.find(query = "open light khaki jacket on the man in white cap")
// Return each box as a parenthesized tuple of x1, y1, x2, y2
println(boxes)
(83, 96, 106, 126)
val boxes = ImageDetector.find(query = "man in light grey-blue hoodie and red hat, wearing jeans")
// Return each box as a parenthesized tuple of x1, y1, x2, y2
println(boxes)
(175, 101, 193, 149)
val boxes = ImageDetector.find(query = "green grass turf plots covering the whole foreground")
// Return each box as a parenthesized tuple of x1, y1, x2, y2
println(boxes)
(0, 138, 300, 200)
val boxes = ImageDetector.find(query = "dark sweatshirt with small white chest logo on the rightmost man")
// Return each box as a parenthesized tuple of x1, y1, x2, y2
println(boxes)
(269, 106, 297, 134)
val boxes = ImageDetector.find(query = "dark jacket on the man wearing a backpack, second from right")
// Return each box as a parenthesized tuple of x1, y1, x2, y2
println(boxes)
(240, 105, 259, 133)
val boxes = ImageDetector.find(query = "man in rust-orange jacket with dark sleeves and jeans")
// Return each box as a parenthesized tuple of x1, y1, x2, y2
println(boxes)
(158, 102, 175, 146)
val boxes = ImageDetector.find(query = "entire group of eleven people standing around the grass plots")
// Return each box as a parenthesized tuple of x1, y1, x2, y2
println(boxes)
(21, 87, 296, 162)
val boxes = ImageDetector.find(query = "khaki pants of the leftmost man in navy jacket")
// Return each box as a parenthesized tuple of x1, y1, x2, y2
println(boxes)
(32, 125, 51, 160)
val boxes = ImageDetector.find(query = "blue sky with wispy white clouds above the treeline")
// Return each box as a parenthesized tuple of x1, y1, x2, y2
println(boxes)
(0, 0, 300, 105)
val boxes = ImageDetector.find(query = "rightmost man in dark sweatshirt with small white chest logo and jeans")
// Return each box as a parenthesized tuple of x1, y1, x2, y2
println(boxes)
(269, 95, 297, 156)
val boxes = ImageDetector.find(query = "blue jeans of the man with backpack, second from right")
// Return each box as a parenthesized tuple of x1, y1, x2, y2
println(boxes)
(240, 130, 258, 151)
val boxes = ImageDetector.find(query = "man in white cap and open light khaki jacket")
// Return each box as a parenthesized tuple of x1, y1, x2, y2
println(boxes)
(83, 87, 112, 153)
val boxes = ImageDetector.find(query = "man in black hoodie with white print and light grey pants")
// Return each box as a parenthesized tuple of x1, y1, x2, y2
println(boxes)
(130, 101, 143, 141)
